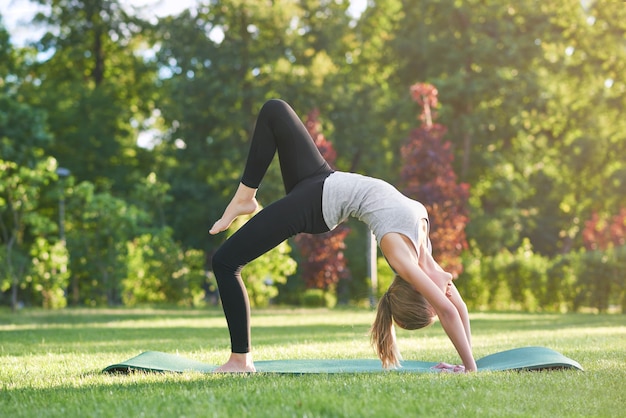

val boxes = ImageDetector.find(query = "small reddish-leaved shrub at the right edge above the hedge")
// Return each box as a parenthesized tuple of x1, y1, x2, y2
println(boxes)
(583, 208, 626, 250)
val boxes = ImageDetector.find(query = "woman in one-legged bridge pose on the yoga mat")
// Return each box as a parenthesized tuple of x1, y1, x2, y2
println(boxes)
(209, 100, 476, 372)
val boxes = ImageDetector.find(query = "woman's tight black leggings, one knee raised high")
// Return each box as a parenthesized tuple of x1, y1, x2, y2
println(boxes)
(213, 100, 333, 353)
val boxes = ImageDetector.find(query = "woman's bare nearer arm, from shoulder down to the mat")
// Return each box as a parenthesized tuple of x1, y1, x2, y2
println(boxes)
(381, 233, 476, 371)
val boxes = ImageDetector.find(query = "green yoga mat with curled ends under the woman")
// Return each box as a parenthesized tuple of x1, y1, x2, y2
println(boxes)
(103, 347, 583, 374)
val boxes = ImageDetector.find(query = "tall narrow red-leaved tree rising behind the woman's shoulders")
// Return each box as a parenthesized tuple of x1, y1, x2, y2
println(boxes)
(401, 83, 469, 274)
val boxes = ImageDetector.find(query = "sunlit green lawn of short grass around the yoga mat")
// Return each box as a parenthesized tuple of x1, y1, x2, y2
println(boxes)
(0, 309, 626, 418)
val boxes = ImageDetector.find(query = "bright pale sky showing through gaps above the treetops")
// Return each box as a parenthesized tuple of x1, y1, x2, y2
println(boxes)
(0, 0, 367, 46)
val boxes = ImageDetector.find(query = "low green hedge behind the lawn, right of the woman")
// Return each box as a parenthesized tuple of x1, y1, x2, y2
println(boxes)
(456, 241, 626, 312)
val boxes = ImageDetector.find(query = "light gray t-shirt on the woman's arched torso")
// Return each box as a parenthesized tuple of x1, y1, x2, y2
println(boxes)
(322, 171, 431, 254)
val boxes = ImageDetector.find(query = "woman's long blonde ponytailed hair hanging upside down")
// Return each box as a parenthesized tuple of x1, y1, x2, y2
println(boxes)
(370, 276, 435, 369)
